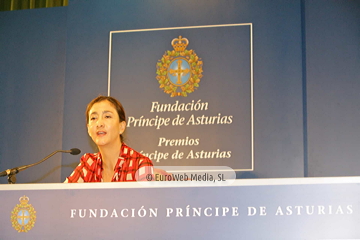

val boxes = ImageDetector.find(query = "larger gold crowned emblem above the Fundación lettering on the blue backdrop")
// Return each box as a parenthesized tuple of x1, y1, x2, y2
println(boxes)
(156, 36, 203, 97)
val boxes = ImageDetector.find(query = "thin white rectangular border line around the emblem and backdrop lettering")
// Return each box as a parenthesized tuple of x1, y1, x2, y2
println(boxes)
(108, 23, 255, 172)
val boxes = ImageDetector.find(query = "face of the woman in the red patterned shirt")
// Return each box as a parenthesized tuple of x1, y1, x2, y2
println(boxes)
(87, 100, 126, 146)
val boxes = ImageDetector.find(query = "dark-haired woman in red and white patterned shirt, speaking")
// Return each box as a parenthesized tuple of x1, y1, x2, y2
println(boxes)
(65, 96, 153, 183)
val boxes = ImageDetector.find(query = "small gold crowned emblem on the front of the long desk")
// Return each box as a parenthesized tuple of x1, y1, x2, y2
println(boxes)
(11, 195, 36, 232)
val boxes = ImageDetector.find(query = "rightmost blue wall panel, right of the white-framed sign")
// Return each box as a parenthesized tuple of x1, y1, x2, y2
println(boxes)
(305, 0, 360, 177)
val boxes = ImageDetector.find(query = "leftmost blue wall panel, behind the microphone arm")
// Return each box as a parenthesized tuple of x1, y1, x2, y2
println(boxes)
(0, 8, 67, 183)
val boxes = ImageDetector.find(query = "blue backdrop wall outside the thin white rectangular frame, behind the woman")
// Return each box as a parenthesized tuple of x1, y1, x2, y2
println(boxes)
(0, 0, 360, 183)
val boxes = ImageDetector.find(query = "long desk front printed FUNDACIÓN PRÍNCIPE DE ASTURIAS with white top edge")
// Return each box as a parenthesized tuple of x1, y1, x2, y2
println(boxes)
(0, 177, 360, 239)
